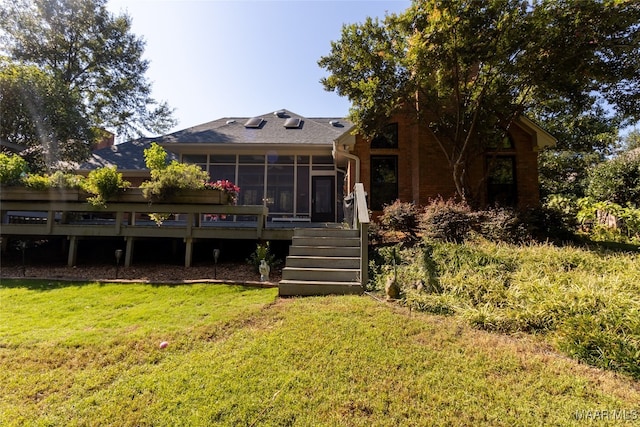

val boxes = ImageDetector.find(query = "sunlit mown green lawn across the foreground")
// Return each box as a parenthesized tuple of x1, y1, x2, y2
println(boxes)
(0, 280, 640, 426)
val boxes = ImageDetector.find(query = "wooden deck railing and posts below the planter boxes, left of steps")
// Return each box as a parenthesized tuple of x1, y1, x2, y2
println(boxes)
(0, 199, 268, 267)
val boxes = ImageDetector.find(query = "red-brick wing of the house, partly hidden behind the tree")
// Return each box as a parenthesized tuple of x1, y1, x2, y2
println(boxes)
(345, 115, 556, 212)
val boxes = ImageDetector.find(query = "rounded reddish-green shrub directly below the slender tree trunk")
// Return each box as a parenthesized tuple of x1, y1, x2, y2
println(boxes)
(419, 199, 478, 243)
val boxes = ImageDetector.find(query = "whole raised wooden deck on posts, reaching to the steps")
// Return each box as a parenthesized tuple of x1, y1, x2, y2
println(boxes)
(0, 200, 339, 267)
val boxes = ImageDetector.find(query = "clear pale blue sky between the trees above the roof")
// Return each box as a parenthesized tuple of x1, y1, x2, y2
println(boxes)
(107, 0, 411, 132)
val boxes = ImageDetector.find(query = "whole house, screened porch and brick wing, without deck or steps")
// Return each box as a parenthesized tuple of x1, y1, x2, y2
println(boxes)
(81, 109, 555, 222)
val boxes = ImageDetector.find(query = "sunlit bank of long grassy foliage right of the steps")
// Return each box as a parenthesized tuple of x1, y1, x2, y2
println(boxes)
(372, 239, 640, 378)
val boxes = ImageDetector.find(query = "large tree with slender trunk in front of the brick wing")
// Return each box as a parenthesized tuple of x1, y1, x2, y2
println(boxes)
(319, 0, 640, 201)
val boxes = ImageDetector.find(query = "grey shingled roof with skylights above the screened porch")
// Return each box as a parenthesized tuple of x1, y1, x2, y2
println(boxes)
(80, 109, 353, 170)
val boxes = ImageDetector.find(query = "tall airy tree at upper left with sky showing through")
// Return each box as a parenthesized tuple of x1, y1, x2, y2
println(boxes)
(0, 0, 175, 137)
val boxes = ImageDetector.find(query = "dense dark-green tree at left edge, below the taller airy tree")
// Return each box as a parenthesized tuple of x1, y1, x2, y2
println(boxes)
(0, 57, 96, 171)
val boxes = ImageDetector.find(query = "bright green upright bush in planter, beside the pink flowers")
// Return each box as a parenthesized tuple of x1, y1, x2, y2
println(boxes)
(140, 143, 209, 200)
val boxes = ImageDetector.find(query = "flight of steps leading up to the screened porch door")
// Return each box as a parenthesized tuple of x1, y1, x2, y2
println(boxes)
(278, 228, 363, 296)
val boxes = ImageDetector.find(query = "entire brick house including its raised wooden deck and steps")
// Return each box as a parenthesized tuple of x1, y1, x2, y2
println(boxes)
(0, 110, 555, 296)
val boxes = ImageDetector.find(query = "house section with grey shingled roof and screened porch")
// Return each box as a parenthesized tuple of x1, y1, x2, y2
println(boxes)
(81, 110, 353, 222)
